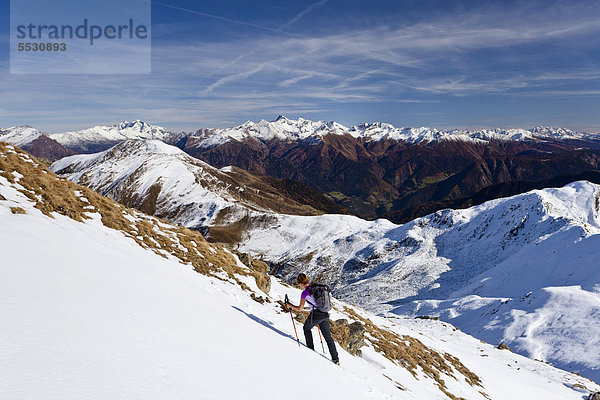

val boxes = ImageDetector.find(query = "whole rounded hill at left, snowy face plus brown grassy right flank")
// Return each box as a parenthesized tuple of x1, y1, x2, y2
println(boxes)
(51, 139, 320, 229)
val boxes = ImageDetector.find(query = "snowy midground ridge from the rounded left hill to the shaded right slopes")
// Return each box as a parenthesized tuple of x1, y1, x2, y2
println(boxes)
(48, 142, 600, 380)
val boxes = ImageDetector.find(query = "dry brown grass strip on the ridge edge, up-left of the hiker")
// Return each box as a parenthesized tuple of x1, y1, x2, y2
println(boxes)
(0, 143, 262, 291)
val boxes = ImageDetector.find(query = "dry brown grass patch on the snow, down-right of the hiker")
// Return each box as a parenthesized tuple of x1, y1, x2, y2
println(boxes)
(344, 307, 481, 400)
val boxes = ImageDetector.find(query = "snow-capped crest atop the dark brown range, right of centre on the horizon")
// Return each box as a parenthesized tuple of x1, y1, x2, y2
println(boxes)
(184, 116, 598, 148)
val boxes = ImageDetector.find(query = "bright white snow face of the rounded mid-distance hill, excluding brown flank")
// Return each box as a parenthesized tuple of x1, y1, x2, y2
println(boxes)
(52, 140, 232, 227)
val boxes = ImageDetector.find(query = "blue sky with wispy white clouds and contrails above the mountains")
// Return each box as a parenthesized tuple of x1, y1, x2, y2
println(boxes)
(0, 0, 600, 132)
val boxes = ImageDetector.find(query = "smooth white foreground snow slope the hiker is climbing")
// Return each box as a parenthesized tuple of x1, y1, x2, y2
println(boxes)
(0, 142, 600, 400)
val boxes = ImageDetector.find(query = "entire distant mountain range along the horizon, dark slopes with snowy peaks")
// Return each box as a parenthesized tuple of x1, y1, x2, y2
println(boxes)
(0, 116, 600, 223)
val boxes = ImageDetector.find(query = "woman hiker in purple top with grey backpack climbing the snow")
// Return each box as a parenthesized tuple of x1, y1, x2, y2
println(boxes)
(286, 273, 340, 365)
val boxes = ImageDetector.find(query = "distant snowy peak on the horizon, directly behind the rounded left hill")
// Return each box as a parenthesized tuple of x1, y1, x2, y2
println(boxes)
(49, 120, 173, 153)
